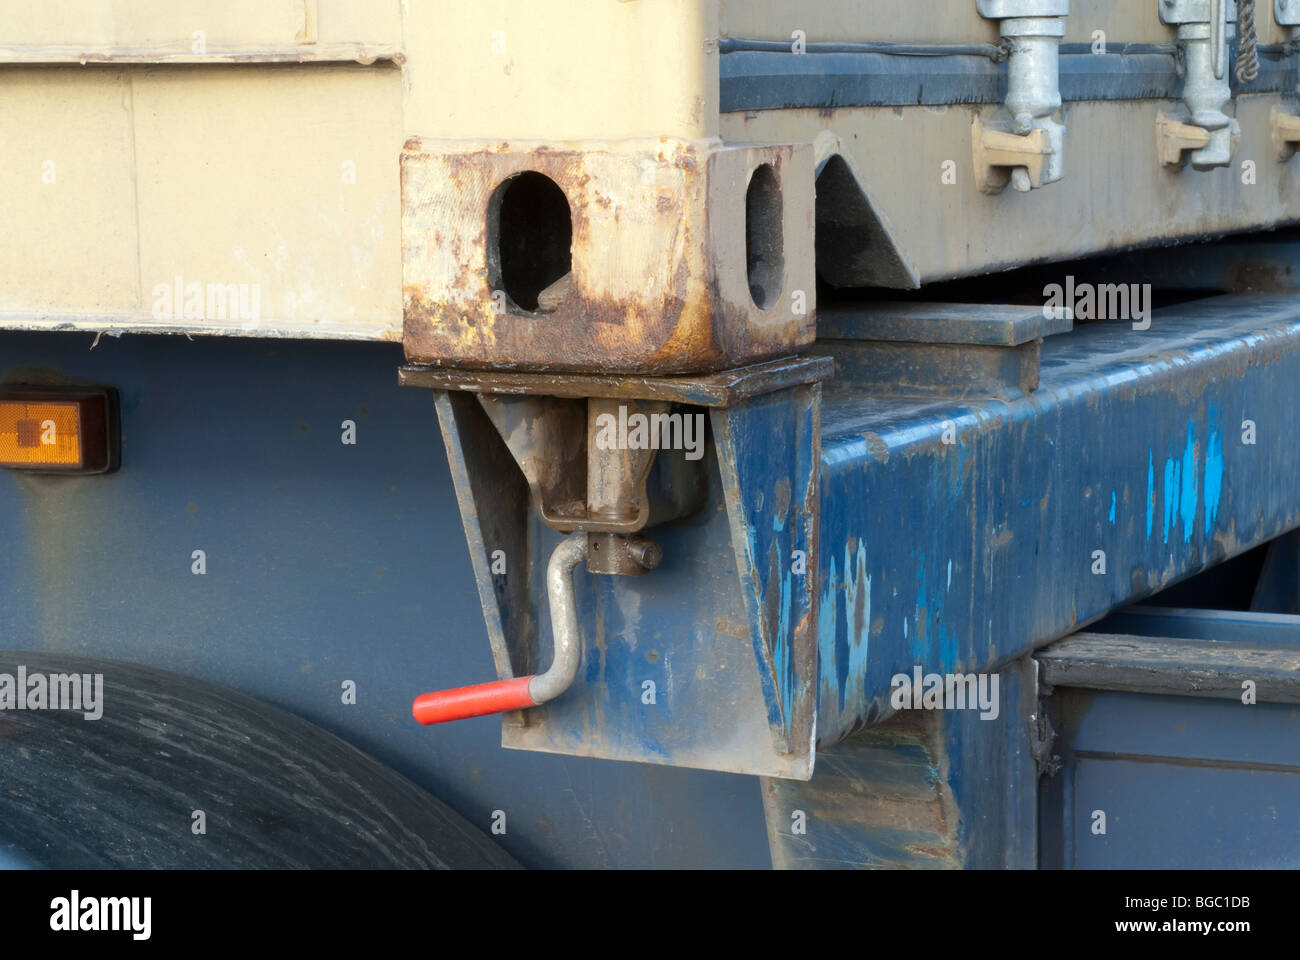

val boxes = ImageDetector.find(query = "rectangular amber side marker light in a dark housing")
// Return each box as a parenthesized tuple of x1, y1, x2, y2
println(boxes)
(0, 385, 121, 475)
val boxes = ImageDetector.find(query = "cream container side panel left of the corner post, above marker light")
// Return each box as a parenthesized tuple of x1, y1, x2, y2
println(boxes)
(0, 65, 403, 340)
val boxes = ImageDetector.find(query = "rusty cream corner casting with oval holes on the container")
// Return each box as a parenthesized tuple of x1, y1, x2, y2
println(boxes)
(402, 139, 815, 375)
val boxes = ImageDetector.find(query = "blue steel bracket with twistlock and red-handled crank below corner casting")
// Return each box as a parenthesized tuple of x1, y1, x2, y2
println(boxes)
(399, 356, 833, 779)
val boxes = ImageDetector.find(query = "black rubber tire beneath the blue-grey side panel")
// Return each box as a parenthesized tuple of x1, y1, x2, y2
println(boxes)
(0, 650, 519, 869)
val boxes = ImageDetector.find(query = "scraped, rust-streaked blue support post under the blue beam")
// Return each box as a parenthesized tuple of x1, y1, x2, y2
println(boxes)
(762, 660, 1039, 870)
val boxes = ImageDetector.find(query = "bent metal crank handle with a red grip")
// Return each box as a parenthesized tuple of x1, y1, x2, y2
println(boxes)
(411, 533, 586, 725)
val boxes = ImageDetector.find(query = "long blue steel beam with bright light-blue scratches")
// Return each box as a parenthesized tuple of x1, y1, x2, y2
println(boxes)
(818, 297, 1300, 745)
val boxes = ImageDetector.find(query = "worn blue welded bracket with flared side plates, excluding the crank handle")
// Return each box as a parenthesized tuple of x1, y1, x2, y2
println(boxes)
(400, 358, 833, 779)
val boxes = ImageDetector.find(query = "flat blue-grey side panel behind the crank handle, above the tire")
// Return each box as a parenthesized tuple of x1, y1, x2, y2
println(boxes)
(0, 333, 770, 868)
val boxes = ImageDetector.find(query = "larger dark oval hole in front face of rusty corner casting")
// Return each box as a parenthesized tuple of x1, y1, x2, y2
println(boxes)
(488, 170, 573, 312)
